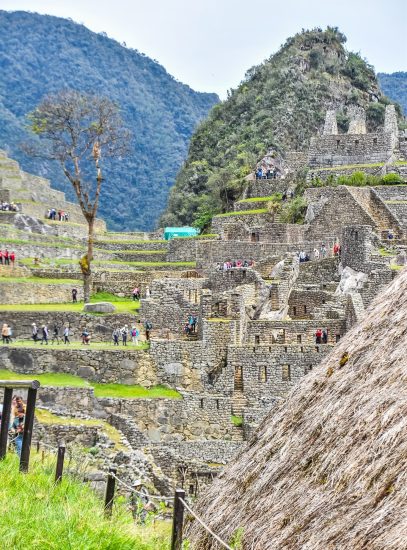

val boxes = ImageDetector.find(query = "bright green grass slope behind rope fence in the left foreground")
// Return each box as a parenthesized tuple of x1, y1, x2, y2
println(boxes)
(0, 454, 169, 550)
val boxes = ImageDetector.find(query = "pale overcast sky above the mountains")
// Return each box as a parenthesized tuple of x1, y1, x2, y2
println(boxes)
(0, 0, 407, 98)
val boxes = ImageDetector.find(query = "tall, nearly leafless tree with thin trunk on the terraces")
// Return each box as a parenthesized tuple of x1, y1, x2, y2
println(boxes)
(28, 90, 129, 302)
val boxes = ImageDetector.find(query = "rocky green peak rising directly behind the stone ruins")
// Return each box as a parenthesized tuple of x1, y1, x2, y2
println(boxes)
(161, 27, 402, 229)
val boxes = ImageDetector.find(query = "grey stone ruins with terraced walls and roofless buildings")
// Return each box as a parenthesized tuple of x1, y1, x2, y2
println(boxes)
(0, 102, 407, 495)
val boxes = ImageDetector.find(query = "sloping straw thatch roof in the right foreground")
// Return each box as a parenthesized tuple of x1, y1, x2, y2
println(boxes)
(187, 270, 407, 550)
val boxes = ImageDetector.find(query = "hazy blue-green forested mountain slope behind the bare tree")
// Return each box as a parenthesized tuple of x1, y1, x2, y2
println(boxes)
(0, 11, 219, 230)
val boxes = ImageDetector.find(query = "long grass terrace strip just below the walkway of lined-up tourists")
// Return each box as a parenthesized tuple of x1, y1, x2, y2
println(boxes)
(0, 369, 182, 399)
